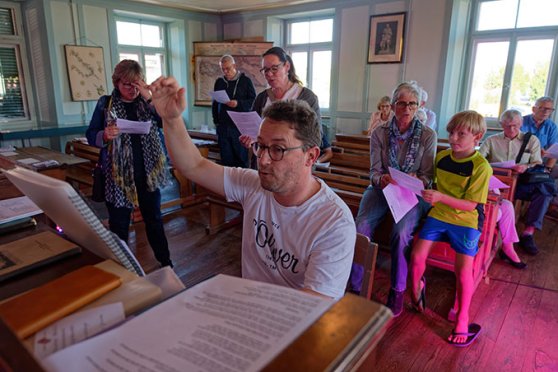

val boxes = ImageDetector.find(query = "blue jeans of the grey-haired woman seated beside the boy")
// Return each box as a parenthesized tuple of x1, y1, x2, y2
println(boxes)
(351, 186, 430, 291)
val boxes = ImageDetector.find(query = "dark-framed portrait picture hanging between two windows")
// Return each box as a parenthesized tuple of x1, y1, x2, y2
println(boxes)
(368, 12, 406, 63)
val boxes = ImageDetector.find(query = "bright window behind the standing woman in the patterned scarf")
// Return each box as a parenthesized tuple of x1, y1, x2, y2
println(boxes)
(116, 18, 167, 83)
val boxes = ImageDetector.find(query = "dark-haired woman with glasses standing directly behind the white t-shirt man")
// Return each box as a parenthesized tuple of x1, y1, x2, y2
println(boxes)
(240, 47, 333, 163)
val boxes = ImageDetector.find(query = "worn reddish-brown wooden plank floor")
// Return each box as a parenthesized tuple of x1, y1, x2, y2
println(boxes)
(130, 206, 558, 372)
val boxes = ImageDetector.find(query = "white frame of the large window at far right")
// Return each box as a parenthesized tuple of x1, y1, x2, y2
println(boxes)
(462, 0, 558, 129)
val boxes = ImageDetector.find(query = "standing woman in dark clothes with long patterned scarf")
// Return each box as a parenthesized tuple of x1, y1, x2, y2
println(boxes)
(86, 59, 172, 266)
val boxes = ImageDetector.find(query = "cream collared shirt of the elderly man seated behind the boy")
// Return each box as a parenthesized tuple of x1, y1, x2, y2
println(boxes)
(479, 132, 542, 164)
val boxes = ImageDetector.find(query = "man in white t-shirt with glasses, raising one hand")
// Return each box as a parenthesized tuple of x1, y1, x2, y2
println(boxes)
(150, 77, 356, 298)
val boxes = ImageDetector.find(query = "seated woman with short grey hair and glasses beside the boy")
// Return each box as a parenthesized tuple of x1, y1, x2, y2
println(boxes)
(350, 82, 436, 316)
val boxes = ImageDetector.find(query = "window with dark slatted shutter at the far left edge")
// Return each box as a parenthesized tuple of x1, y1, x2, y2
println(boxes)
(0, 5, 29, 122)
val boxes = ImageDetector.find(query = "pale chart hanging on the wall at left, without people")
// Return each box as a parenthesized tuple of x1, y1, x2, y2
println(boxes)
(64, 45, 107, 101)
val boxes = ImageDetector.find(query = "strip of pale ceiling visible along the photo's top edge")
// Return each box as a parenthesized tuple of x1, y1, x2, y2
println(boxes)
(130, 0, 320, 13)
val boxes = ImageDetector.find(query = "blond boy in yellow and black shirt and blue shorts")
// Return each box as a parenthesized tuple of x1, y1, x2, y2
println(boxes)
(410, 111, 492, 346)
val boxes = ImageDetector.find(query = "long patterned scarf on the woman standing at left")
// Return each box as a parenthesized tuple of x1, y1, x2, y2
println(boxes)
(107, 89, 168, 208)
